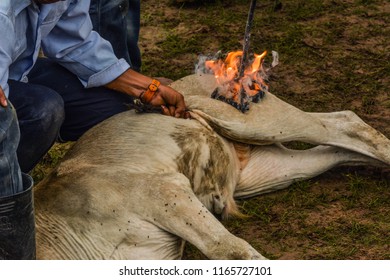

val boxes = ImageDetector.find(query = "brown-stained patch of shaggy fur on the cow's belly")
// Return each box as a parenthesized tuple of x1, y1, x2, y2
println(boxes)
(171, 127, 236, 217)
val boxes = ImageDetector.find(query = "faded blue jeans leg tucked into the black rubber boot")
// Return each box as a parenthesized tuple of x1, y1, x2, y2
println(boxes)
(0, 102, 23, 197)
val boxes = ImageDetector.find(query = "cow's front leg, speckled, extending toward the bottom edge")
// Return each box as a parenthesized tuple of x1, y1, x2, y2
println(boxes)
(133, 173, 265, 259)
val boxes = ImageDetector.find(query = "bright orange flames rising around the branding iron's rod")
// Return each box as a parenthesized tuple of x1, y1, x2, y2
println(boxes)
(205, 51, 268, 102)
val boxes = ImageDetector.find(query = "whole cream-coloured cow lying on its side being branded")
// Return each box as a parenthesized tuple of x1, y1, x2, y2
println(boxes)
(35, 75, 390, 259)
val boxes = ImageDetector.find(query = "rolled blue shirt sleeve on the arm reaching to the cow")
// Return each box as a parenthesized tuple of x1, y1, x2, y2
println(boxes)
(42, 0, 130, 87)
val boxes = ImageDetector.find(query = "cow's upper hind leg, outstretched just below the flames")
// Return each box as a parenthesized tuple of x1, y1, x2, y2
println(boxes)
(190, 97, 390, 165)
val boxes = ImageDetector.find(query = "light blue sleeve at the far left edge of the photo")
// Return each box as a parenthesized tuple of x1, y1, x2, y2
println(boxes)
(0, 12, 16, 97)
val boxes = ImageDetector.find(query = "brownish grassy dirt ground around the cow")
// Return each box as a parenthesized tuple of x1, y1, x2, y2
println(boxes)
(136, 0, 390, 259)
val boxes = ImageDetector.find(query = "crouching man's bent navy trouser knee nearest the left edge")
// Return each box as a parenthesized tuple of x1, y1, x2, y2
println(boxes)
(8, 80, 64, 173)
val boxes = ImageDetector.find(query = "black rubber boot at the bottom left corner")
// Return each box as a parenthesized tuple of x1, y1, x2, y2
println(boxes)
(0, 174, 35, 260)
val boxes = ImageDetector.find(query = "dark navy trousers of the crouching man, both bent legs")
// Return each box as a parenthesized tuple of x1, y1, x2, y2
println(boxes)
(9, 58, 133, 173)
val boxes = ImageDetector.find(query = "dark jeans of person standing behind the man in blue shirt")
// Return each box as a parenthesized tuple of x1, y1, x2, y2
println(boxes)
(89, 0, 141, 71)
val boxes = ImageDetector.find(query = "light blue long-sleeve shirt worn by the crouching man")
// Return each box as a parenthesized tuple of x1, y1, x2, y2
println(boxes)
(0, 0, 130, 97)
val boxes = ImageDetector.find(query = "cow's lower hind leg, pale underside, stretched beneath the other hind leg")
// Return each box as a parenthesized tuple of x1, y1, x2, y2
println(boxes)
(234, 145, 383, 198)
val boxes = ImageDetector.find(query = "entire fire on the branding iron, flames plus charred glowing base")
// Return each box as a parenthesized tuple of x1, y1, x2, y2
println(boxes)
(200, 51, 268, 111)
